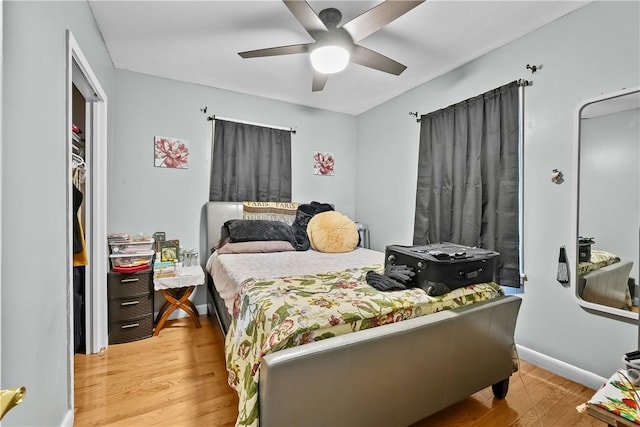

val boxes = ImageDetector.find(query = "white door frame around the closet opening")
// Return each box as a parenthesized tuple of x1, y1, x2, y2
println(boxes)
(66, 30, 108, 421)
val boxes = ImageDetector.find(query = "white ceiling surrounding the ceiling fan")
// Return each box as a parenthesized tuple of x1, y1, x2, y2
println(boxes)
(89, 0, 589, 115)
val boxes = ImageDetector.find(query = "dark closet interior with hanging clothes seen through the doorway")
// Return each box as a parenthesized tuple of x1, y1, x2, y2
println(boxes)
(69, 86, 90, 353)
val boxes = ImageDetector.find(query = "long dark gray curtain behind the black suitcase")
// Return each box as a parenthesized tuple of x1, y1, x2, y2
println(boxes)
(413, 82, 520, 287)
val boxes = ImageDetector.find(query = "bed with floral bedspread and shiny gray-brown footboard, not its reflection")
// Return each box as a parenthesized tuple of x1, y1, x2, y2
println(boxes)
(206, 202, 521, 426)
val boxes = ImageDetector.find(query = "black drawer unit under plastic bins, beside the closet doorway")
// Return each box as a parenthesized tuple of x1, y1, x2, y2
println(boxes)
(107, 269, 154, 344)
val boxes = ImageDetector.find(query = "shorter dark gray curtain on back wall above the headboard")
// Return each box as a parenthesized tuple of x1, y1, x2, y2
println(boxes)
(209, 119, 291, 202)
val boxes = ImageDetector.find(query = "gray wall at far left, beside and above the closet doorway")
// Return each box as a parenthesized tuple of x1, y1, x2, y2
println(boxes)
(1, 1, 113, 426)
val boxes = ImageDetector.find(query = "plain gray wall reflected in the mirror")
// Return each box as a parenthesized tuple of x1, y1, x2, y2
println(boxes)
(579, 108, 640, 283)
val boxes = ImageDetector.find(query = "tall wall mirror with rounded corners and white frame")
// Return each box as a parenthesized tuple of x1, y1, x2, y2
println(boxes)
(572, 87, 640, 319)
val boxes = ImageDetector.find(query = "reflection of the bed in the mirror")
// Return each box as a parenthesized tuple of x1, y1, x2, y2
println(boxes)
(578, 249, 633, 310)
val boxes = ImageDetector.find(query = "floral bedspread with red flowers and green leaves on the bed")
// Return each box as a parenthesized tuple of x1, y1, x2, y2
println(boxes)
(225, 265, 504, 426)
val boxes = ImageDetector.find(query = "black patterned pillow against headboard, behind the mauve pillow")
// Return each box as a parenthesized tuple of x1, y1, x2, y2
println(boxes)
(224, 219, 296, 246)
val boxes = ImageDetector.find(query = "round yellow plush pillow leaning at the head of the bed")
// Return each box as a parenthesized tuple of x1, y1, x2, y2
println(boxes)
(307, 211, 360, 253)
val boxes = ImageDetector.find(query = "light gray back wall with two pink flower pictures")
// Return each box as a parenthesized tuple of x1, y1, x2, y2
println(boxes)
(108, 71, 357, 308)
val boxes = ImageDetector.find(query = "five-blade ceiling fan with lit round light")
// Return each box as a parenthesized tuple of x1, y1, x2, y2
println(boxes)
(238, 0, 424, 92)
